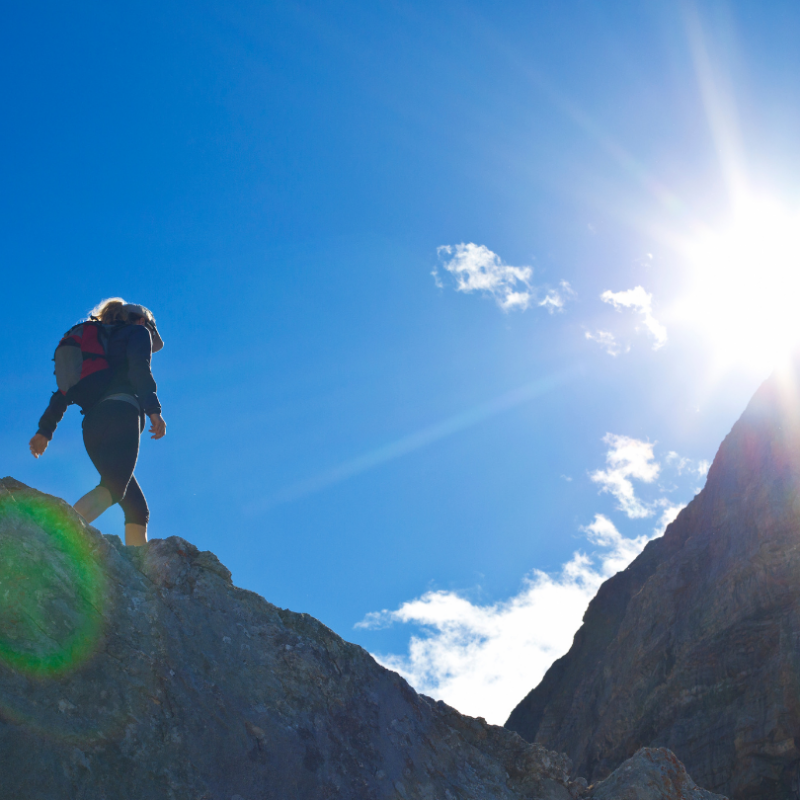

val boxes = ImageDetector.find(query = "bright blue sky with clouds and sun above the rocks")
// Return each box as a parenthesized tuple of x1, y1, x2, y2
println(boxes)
(0, 0, 800, 722)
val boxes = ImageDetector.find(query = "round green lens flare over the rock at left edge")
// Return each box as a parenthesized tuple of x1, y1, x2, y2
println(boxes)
(0, 493, 107, 677)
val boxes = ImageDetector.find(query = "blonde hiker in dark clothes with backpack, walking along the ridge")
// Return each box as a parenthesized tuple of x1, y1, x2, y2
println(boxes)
(30, 297, 167, 546)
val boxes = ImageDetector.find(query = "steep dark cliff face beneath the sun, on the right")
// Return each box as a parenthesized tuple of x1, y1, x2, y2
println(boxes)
(506, 370, 800, 800)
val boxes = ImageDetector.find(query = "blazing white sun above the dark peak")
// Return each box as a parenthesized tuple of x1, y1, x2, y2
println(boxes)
(679, 197, 800, 371)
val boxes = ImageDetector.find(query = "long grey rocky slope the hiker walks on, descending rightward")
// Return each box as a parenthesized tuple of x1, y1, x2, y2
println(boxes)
(0, 478, 724, 800)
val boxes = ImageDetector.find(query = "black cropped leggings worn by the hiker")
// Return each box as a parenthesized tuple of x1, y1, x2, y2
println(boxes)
(83, 400, 150, 525)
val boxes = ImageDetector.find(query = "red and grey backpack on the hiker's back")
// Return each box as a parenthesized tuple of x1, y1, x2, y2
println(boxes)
(53, 319, 115, 398)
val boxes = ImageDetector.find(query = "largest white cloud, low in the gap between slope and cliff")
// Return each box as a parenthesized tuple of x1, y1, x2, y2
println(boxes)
(357, 514, 648, 725)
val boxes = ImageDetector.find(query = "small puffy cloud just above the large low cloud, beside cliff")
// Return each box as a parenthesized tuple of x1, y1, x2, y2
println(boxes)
(589, 433, 661, 519)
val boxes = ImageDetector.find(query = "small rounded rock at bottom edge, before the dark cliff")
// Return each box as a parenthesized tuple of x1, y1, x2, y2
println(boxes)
(589, 747, 721, 800)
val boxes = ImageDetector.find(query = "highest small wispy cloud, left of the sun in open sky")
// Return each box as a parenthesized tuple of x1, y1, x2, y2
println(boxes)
(431, 242, 575, 314)
